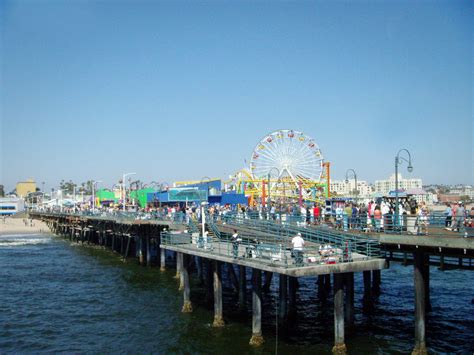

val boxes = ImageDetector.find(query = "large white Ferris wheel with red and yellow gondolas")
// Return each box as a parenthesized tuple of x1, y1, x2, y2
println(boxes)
(250, 129, 323, 184)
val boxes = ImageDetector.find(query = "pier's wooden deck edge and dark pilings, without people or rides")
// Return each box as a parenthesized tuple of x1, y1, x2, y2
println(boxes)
(30, 213, 474, 354)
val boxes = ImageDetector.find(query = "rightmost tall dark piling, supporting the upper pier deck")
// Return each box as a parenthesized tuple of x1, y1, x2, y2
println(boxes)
(412, 251, 428, 355)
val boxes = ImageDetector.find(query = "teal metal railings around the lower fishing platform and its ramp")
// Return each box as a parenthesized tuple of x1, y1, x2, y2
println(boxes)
(162, 210, 382, 268)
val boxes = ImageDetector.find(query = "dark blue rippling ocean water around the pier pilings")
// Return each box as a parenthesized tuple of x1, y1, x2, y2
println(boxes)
(0, 235, 474, 354)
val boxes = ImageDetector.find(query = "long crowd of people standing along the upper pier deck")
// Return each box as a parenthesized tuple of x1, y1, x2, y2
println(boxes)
(34, 199, 474, 238)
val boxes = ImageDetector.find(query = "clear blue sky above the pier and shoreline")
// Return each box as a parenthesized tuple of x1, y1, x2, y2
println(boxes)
(0, 0, 474, 190)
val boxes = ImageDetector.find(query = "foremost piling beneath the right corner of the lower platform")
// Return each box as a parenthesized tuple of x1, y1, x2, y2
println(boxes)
(332, 274, 347, 355)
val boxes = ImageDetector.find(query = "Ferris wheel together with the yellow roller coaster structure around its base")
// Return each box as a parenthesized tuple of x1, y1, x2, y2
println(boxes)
(226, 129, 330, 205)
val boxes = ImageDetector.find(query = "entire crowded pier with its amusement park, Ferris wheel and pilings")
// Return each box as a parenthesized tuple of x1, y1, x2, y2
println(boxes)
(15, 130, 474, 354)
